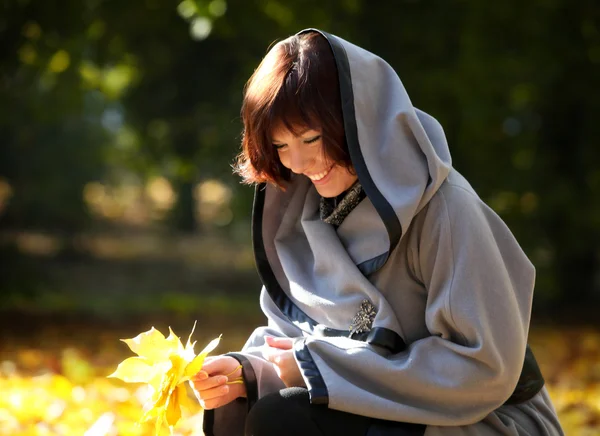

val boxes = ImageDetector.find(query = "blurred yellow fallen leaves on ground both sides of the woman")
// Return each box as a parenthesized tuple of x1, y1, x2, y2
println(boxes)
(0, 327, 600, 436)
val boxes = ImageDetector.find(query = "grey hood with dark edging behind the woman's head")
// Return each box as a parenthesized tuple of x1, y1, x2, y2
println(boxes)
(253, 29, 452, 275)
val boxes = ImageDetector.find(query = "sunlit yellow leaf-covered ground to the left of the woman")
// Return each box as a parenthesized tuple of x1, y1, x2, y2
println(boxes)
(0, 315, 258, 436)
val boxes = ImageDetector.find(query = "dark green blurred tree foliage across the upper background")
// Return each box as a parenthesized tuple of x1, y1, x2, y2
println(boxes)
(0, 0, 600, 301)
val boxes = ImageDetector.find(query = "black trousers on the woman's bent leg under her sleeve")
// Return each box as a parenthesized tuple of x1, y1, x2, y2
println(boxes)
(245, 388, 425, 436)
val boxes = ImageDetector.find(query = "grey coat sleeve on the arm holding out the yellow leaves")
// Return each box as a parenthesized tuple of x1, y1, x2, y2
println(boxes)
(203, 288, 302, 436)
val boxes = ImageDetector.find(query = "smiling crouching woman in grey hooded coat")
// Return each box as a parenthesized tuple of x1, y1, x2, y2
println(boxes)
(195, 29, 562, 436)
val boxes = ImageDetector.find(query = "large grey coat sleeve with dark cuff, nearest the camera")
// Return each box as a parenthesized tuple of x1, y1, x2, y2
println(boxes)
(294, 185, 535, 426)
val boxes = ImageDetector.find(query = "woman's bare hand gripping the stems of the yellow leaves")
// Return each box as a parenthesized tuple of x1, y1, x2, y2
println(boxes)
(192, 356, 246, 410)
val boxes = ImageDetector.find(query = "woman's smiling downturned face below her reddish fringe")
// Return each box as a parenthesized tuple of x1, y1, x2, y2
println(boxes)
(271, 126, 357, 197)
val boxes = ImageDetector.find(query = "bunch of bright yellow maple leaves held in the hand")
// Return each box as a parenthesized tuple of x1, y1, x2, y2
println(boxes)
(109, 323, 243, 435)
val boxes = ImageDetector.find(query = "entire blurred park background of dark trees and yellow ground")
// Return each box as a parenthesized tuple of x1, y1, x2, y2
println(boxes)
(0, 0, 600, 436)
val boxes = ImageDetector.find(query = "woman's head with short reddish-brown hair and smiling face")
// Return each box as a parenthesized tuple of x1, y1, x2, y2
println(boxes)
(236, 33, 356, 192)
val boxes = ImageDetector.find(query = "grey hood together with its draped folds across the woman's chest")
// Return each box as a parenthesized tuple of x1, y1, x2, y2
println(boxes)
(252, 29, 451, 348)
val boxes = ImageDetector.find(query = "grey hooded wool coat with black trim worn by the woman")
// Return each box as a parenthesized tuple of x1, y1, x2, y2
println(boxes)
(205, 29, 562, 436)
